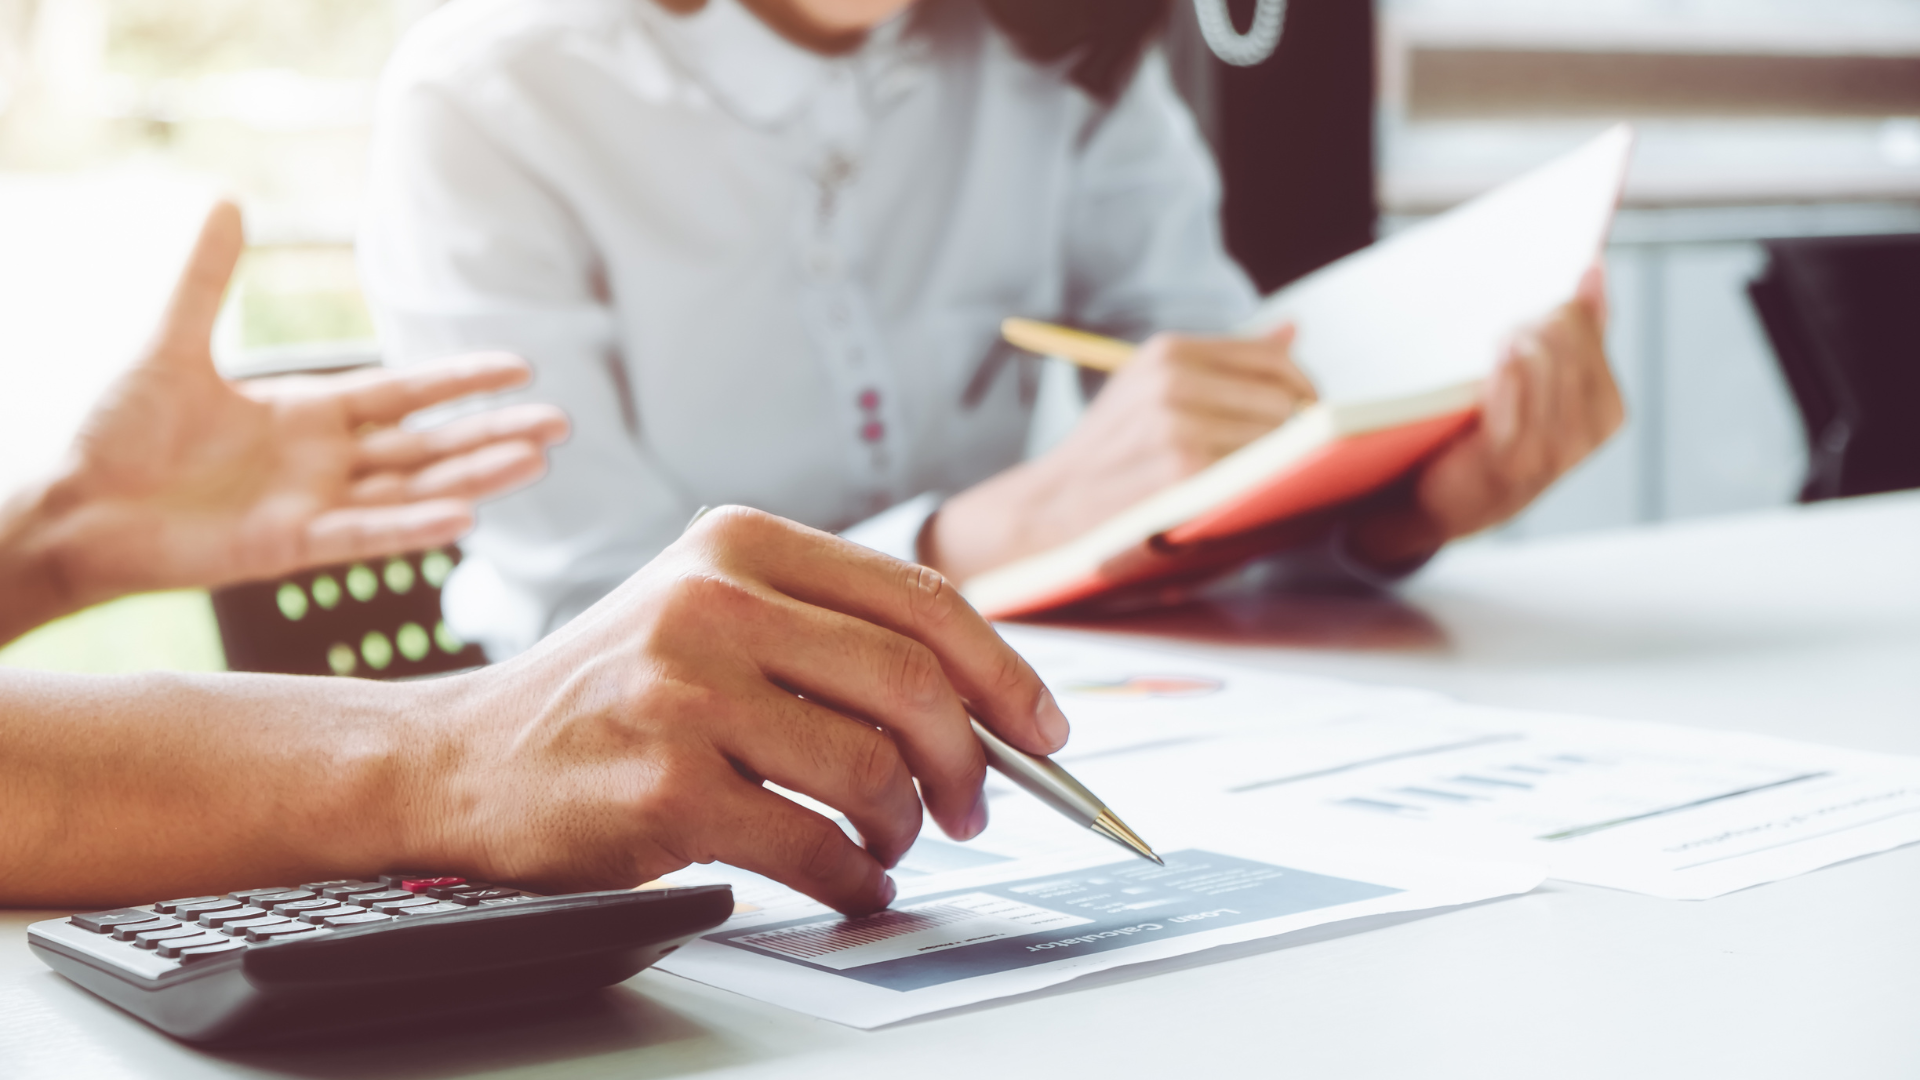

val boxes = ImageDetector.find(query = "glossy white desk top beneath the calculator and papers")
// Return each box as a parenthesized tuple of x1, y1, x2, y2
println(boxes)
(0, 494, 1920, 1080)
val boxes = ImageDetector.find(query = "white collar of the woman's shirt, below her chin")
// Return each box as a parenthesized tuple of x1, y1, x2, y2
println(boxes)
(641, 0, 924, 125)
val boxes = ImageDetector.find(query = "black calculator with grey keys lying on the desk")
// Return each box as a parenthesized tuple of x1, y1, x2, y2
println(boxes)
(27, 874, 733, 1043)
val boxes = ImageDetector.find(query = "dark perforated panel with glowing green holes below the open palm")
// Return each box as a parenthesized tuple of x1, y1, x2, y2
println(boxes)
(213, 548, 486, 678)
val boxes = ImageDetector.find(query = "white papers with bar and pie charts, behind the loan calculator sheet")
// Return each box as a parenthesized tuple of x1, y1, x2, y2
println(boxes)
(985, 628, 1920, 899)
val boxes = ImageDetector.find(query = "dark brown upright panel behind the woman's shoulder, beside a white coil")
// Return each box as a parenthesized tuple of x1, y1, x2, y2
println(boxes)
(1221, 0, 1380, 292)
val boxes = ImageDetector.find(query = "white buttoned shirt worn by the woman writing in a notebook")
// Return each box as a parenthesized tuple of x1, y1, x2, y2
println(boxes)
(361, 0, 1254, 657)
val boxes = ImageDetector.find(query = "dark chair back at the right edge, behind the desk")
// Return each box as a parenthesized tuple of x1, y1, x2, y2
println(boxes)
(1747, 234, 1920, 502)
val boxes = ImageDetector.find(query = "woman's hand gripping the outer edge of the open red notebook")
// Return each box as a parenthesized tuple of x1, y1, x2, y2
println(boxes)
(1348, 263, 1626, 569)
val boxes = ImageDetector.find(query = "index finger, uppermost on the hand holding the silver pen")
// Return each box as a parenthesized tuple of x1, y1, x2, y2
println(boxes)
(687, 507, 1068, 753)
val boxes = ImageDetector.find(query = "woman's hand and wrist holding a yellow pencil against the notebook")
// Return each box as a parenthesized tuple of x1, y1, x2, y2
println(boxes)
(922, 325, 1315, 580)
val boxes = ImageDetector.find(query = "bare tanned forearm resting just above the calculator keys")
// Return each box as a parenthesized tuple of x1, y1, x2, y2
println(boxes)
(0, 671, 449, 907)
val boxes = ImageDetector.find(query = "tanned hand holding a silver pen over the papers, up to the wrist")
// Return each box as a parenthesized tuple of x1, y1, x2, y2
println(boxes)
(415, 507, 1068, 913)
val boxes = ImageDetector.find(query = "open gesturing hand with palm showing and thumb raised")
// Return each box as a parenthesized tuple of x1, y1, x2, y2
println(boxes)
(24, 204, 566, 609)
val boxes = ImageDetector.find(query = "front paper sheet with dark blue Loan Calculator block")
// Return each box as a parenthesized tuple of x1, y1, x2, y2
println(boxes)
(659, 842, 1540, 1028)
